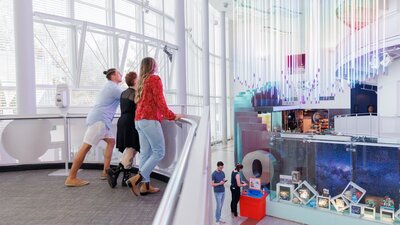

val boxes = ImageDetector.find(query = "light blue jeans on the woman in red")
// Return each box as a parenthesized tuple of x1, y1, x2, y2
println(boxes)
(135, 120, 165, 182)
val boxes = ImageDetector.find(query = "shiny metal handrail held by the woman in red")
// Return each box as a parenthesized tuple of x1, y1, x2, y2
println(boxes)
(153, 118, 198, 225)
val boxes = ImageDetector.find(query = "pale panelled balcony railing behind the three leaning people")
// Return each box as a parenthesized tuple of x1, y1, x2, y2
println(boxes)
(0, 114, 195, 176)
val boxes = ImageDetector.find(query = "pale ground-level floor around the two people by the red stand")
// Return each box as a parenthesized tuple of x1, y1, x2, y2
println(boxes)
(211, 141, 299, 225)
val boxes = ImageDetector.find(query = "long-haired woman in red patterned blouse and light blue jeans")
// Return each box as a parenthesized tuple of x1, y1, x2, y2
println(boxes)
(127, 57, 181, 196)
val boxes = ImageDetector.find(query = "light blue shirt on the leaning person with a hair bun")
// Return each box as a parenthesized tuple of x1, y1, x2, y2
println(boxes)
(86, 80, 122, 129)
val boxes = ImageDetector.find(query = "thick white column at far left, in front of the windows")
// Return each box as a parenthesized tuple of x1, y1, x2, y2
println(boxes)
(13, 0, 36, 115)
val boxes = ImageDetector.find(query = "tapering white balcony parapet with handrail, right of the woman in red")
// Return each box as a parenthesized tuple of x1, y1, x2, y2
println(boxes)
(153, 107, 212, 225)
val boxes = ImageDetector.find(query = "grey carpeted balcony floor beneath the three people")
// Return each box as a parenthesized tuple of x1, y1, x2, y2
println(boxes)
(0, 170, 166, 225)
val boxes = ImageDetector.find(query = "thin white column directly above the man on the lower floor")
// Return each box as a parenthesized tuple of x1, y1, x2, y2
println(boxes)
(220, 12, 228, 143)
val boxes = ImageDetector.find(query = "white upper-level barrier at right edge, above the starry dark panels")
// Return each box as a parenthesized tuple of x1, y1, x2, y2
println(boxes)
(335, 113, 400, 143)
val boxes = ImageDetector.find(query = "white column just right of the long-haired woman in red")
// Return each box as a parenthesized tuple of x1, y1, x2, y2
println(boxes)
(174, 0, 187, 114)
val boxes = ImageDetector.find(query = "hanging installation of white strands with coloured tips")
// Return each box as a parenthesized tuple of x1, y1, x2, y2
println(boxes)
(233, 0, 390, 104)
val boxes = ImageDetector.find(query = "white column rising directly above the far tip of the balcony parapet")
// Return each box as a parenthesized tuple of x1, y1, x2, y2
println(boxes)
(201, 0, 210, 106)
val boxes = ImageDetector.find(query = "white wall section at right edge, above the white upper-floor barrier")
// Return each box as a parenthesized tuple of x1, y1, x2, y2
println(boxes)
(378, 60, 400, 116)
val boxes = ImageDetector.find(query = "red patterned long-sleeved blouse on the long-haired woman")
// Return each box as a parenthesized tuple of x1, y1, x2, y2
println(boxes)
(135, 75, 175, 122)
